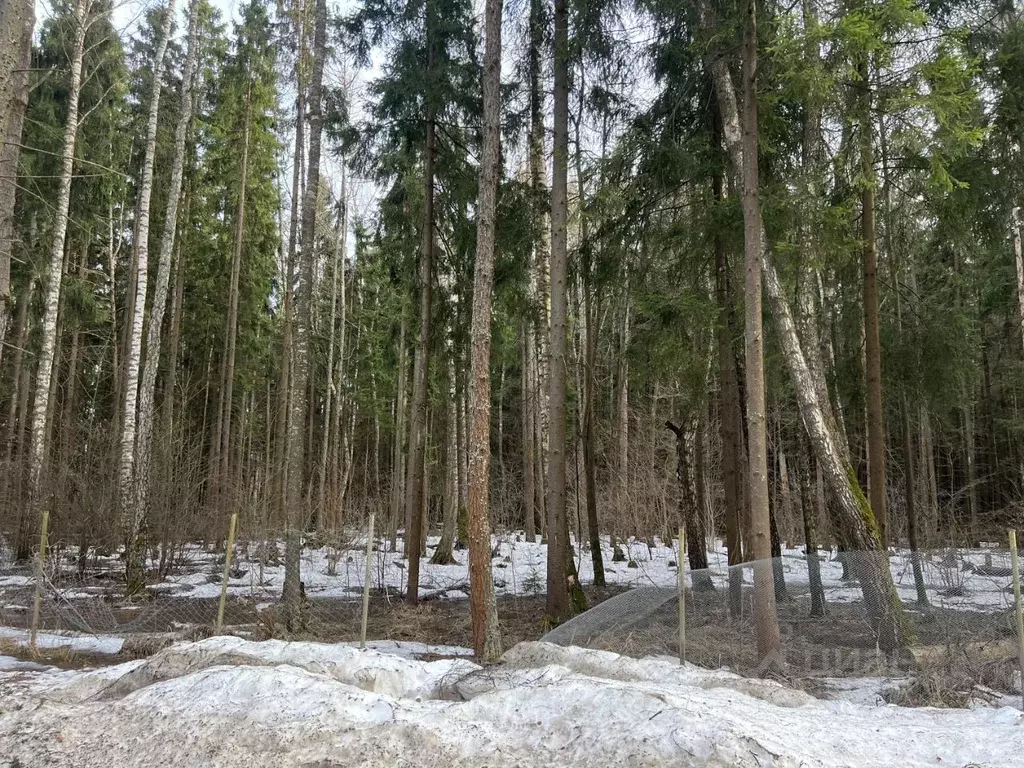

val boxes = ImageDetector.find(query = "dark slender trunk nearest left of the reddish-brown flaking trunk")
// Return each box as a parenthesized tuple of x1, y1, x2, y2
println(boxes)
(406, 7, 437, 605)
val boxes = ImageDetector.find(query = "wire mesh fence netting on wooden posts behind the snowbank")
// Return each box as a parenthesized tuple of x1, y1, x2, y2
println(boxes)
(0, 527, 1020, 702)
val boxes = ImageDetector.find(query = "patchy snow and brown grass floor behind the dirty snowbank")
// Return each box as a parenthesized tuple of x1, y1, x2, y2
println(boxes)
(0, 534, 1017, 706)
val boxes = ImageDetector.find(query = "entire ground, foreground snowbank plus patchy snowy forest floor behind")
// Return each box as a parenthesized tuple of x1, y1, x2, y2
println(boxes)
(0, 536, 1024, 768)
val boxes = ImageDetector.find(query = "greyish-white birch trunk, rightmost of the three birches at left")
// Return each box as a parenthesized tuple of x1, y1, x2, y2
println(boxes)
(129, 0, 201, 541)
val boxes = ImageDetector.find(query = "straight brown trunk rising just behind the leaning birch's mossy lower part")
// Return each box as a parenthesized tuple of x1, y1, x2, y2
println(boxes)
(858, 53, 889, 550)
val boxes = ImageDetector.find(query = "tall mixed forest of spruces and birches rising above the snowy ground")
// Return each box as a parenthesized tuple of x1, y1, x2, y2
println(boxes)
(0, 0, 1024, 658)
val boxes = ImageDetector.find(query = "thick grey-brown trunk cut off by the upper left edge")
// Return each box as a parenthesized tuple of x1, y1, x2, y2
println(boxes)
(0, 0, 36, 360)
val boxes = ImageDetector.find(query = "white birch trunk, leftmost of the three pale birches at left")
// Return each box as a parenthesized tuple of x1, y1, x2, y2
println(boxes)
(26, 0, 92, 524)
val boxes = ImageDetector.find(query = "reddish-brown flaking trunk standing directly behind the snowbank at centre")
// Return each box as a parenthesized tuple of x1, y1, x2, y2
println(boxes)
(467, 0, 502, 662)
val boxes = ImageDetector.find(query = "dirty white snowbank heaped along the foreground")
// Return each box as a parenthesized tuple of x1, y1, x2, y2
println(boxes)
(0, 637, 1024, 768)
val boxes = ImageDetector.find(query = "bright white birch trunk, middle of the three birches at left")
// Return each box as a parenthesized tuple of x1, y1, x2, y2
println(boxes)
(118, 0, 175, 595)
